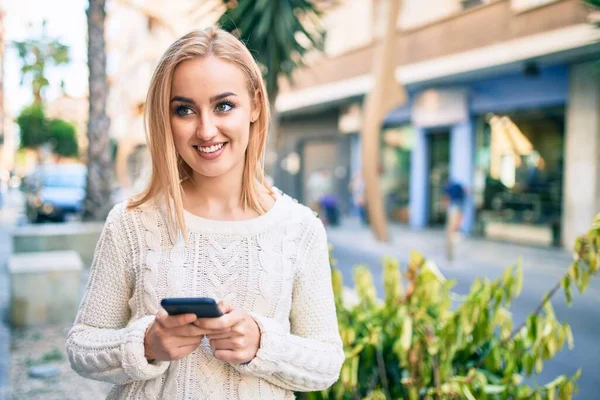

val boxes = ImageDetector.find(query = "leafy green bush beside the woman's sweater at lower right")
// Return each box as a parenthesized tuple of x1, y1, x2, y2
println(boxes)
(304, 215, 600, 400)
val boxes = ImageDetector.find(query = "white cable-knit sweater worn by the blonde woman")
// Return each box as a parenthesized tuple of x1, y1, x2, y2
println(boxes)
(67, 194, 344, 400)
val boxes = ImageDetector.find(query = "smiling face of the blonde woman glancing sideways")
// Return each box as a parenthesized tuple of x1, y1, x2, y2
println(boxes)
(169, 56, 260, 178)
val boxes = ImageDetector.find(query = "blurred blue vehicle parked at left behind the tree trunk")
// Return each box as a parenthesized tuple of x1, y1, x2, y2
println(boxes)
(24, 164, 87, 223)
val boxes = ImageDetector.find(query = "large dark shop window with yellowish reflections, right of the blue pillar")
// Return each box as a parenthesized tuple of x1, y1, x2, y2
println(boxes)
(474, 108, 564, 245)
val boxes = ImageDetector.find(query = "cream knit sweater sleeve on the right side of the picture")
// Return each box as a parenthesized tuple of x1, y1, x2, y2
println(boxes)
(235, 218, 344, 392)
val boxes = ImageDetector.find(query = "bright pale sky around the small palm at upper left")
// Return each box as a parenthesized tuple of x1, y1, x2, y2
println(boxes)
(0, 0, 88, 116)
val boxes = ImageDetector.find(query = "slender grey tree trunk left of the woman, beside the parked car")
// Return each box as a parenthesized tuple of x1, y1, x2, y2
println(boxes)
(84, 0, 112, 221)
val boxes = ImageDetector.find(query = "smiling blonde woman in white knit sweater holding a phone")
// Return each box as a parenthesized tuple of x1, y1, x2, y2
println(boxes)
(67, 28, 344, 399)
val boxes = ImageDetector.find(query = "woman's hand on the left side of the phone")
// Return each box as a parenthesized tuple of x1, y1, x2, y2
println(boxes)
(144, 308, 230, 361)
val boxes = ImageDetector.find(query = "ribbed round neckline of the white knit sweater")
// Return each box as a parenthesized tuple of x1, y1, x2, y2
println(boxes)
(183, 187, 286, 235)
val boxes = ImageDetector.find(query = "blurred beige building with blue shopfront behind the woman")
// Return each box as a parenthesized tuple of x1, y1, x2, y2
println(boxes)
(276, 0, 600, 245)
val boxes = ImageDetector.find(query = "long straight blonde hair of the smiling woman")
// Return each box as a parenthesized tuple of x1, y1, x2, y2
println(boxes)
(128, 27, 272, 240)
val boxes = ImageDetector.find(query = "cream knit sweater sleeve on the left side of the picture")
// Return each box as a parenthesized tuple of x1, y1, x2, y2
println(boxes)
(67, 205, 169, 384)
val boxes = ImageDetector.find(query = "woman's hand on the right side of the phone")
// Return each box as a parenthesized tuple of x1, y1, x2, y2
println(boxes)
(194, 302, 260, 364)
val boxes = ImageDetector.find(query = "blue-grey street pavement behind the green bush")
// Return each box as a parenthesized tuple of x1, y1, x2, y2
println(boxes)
(328, 219, 600, 399)
